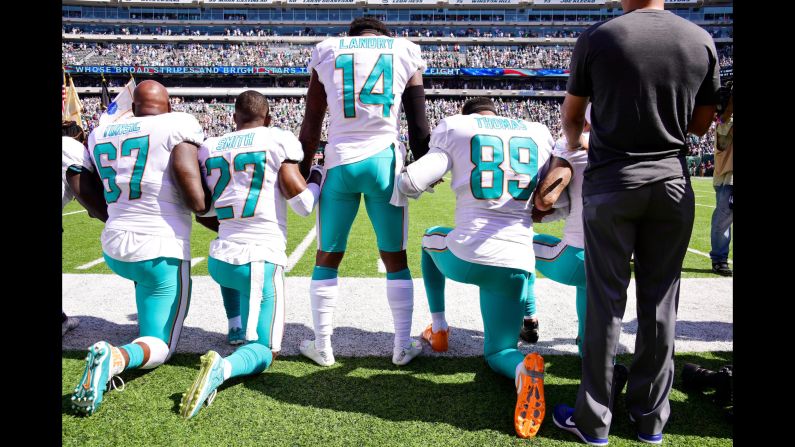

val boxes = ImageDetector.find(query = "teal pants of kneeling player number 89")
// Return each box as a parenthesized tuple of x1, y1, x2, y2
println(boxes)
(421, 231, 529, 379)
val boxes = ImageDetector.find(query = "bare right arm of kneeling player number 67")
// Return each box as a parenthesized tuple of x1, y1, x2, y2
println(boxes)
(171, 141, 211, 214)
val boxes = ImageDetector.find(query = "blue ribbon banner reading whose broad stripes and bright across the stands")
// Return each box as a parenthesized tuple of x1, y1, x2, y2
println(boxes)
(64, 65, 569, 77)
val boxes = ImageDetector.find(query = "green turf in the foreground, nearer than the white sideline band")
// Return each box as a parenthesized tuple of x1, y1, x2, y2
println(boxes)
(62, 352, 733, 447)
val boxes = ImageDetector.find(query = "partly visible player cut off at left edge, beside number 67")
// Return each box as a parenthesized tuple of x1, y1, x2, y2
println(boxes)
(61, 121, 108, 336)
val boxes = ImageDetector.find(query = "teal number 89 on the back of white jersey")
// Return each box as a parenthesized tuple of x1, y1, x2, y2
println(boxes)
(469, 134, 538, 200)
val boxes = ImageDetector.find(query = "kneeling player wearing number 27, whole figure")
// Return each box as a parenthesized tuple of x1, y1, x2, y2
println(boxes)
(180, 90, 320, 418)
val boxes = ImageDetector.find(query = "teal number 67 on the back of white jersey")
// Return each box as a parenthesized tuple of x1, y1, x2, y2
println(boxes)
(94, 135, 149, 204)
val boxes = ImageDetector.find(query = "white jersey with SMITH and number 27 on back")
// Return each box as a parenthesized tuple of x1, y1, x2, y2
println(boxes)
(199, 127, 304, 266)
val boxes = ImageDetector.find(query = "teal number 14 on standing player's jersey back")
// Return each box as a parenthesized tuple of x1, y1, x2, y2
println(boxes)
(334, 54, 395, 118)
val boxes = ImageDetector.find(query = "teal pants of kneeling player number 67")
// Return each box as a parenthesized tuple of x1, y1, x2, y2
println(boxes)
(103, 253, 191, 355)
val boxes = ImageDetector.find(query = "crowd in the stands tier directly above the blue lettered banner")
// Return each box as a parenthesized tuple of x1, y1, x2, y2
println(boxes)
(61, 42, 733, 68)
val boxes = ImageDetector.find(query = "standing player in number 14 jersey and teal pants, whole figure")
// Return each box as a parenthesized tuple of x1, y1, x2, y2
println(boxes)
(299, 17, 430, 366)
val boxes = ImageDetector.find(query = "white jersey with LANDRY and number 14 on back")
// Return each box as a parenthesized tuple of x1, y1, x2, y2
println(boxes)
(308, 36, 427, 169)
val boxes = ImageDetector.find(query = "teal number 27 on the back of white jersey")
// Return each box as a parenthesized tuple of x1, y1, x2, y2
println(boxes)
(204, 151, 267, 220)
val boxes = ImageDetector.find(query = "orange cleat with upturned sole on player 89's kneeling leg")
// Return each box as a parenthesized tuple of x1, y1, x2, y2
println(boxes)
(513, 352, 546, 438)
